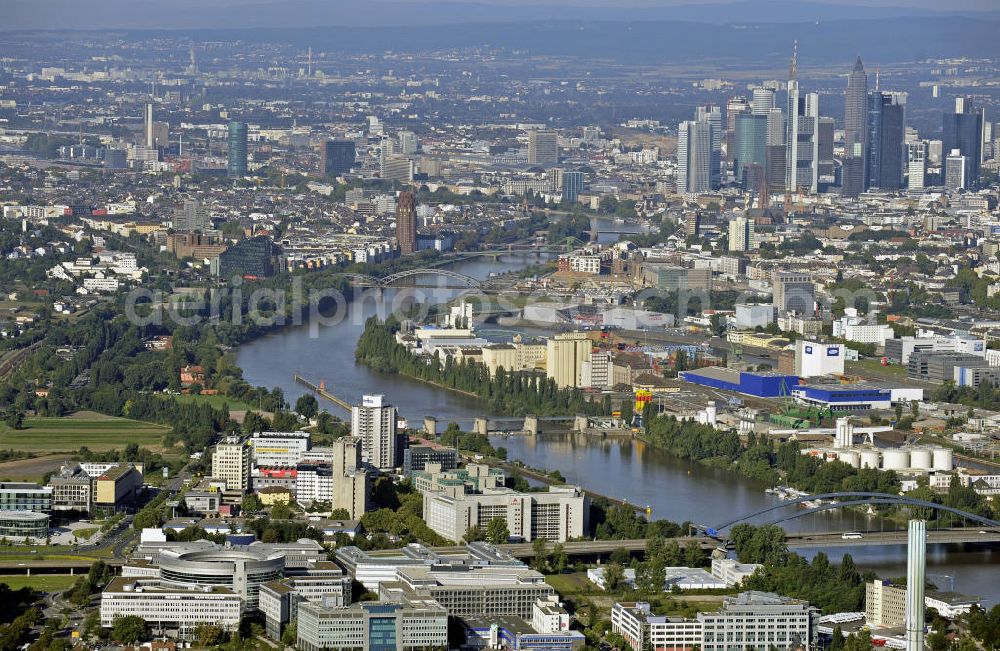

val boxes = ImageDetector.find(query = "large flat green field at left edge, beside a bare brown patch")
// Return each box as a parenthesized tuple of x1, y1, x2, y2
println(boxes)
(0, 412, 169, 453)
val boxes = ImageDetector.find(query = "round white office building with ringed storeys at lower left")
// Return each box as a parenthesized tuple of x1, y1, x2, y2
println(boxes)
(159, 545, 285, 610)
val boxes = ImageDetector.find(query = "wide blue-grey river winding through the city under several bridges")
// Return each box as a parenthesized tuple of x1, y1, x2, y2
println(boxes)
(237, 255, 1000, 604)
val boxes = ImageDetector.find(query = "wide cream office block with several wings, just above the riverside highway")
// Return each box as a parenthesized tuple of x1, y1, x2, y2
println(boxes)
(423, 486, 589, 542)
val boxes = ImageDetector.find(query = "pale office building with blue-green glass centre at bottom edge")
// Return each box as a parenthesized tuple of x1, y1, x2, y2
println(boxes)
(295, 599, 449, 651)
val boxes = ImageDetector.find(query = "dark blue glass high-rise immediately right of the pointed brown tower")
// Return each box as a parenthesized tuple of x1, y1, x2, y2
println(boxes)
(867, 90, 906, 190)
